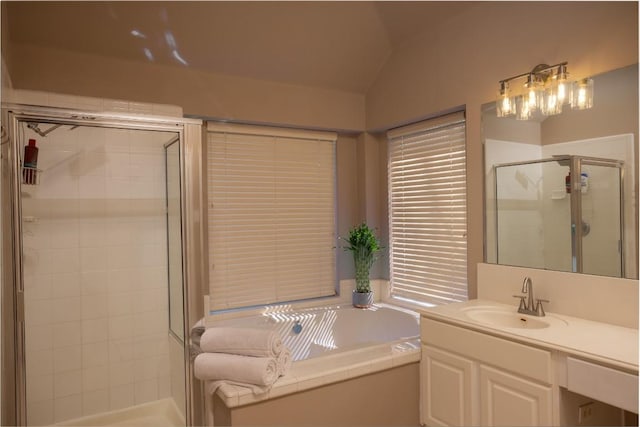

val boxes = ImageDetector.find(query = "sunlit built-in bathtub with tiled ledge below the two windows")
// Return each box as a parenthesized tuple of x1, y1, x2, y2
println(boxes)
(207, 303, 420, 425)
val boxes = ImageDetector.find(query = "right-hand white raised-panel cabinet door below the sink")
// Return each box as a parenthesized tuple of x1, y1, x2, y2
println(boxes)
(480, 365, 553, 426)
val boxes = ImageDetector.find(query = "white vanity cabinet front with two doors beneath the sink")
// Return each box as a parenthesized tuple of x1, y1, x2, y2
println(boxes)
(421, 317, 557, 426)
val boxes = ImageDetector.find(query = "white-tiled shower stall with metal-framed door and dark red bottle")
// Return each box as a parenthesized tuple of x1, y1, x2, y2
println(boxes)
(0, 106, 200, 426)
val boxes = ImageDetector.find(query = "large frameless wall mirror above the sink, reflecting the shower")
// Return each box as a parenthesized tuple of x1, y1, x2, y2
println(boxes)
(482, 64, 638, 279)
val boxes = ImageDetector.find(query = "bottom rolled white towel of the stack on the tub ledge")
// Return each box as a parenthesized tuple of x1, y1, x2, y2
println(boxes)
(193, 353, 278, 387)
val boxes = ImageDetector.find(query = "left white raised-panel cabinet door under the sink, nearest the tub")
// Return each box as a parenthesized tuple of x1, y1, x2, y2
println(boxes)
(420, 345, 477, 426)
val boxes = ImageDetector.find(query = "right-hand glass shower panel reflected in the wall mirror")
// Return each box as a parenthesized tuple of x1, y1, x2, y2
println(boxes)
(581, 160, 624, 277)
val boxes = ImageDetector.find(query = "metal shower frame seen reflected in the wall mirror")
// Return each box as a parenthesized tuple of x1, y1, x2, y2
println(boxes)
(496, 155, 625, 278)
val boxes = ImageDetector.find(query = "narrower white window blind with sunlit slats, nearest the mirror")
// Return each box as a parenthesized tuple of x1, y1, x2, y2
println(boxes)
(388, 112, 467, 305)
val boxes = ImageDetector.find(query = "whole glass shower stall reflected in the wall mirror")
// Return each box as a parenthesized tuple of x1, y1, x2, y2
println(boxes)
(494, 155, 625, 277)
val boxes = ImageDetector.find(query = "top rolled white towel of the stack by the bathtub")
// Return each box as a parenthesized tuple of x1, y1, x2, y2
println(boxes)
(200, 327, 282, 357)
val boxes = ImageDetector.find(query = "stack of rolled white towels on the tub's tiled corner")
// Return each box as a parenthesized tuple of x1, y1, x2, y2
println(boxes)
(194, 327, 291, 392)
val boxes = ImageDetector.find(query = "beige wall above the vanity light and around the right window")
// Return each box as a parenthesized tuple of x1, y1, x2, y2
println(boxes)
(366, 2, 638, 297)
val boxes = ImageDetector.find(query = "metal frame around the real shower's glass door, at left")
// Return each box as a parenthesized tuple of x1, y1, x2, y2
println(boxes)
(1, 104, 203, 426)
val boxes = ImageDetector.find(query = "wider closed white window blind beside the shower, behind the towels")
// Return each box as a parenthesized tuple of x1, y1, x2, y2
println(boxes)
(207, 123, 336, 310)
